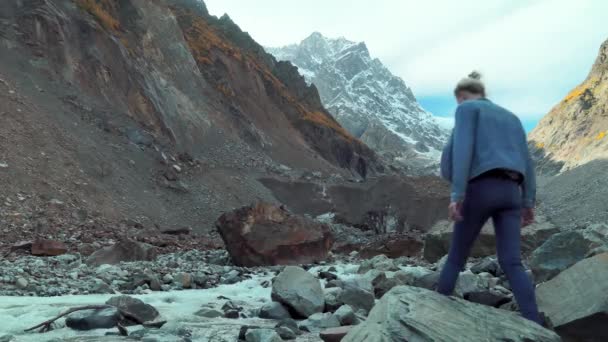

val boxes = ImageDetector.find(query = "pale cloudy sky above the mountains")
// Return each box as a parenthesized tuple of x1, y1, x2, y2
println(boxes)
(205, 0, 608, 129)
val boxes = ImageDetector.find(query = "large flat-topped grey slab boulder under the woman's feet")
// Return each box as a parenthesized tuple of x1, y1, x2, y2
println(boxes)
(342, 286, 561, 342)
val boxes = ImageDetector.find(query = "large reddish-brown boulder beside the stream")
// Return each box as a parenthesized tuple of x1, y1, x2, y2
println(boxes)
(216, 203, 333, 267)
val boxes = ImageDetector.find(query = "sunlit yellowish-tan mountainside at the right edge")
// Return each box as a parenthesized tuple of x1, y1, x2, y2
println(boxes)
(529, 41, 608, 173)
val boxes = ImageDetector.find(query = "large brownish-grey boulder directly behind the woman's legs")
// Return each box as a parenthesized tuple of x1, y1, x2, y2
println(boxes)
(423, 217, 559, 262)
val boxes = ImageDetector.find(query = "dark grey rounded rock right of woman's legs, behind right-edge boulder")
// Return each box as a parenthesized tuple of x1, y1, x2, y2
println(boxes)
(530, 231, 593, 282)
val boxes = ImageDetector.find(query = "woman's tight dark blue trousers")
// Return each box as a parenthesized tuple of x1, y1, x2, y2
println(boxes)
(437, 178, 541, 324)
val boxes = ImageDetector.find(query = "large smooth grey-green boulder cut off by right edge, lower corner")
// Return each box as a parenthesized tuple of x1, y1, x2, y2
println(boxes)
(536, 253, 608, 342)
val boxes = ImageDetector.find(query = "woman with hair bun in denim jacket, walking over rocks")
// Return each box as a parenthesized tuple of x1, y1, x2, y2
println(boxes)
(437, 72, 541, 324)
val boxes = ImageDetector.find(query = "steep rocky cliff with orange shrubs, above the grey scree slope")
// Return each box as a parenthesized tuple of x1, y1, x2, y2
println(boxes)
(0, 0, 377, 176)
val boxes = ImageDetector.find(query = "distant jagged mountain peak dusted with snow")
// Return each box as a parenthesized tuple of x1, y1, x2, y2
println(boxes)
(267, 32, 447, 171)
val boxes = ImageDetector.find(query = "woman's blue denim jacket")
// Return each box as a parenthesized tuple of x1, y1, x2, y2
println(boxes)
(441, 98, 536, 208)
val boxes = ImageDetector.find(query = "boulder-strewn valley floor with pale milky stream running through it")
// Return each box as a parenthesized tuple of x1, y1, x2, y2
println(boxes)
(0, 200, 608, 342)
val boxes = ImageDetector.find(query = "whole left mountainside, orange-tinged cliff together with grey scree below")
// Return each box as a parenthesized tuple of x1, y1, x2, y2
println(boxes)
(0, 0, 383, 235)
